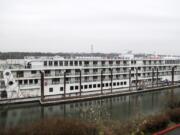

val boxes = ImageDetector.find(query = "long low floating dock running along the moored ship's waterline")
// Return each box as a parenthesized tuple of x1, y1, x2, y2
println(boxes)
(0, 84, 180, 106)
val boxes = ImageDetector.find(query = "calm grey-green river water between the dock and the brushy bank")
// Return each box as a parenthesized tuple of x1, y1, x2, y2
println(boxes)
(0, 88, 180, 128)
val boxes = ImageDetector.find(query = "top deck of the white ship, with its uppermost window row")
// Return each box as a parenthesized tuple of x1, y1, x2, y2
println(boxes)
(0, 55, 180, 71)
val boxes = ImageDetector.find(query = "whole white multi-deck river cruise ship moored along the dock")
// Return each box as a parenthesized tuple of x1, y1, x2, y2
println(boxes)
(0, 54, 180, 100)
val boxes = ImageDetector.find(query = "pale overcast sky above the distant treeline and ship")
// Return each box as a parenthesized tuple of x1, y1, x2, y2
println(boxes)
(0, 0, 180, 54)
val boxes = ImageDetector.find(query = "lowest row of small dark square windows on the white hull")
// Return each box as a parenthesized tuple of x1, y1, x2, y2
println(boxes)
(49, 81, 127, 92)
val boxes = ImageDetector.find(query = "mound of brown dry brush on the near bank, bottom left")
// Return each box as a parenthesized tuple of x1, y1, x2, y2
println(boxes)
(0, 118, 99, 135)
